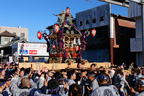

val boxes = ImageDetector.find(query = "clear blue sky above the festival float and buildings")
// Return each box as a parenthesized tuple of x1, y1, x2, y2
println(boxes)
(0, 0, 127, 42)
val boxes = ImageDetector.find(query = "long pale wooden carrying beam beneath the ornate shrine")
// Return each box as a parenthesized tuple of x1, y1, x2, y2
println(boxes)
(19, 62, 111, 70)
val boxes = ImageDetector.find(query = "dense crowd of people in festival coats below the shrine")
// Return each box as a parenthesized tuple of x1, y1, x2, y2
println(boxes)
(0, 63, 144, 96)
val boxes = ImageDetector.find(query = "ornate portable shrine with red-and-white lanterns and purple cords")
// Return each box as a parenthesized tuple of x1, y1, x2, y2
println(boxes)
(37, 7, 96, 64)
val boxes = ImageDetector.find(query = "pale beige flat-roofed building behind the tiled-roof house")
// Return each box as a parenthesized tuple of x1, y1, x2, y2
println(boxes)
(0, 26, 28, 40)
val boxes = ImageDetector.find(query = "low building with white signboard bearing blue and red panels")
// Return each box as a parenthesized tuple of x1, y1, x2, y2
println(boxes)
(0, 37, 49, 62)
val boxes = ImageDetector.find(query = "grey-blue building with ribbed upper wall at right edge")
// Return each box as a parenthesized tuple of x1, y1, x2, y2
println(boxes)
(128, 1, 144, 66)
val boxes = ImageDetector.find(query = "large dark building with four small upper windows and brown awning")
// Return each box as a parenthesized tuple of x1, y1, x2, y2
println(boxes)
(76, 4, 136, 65)
